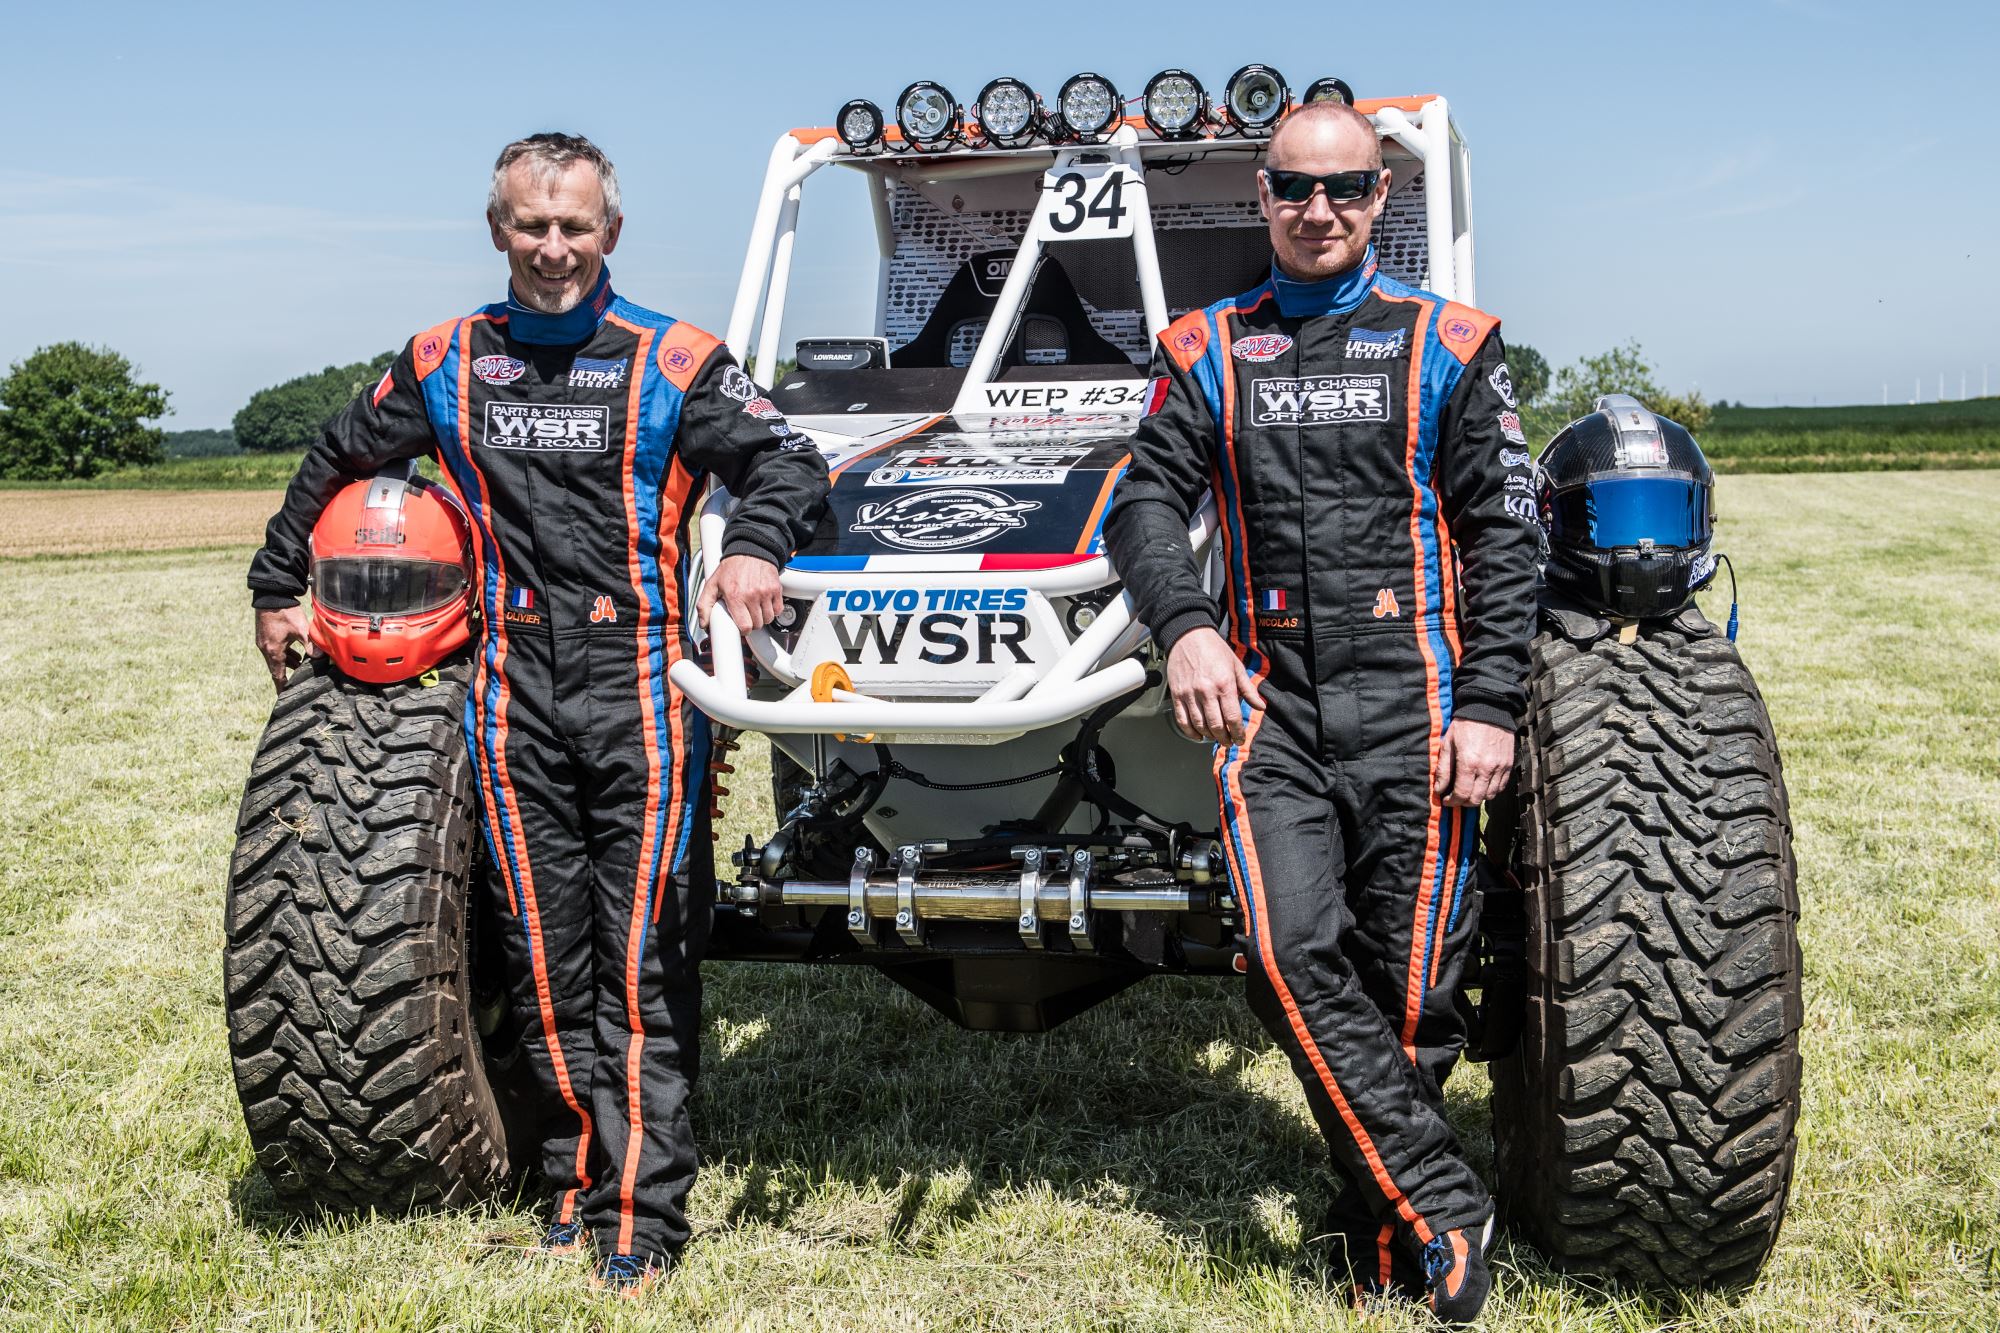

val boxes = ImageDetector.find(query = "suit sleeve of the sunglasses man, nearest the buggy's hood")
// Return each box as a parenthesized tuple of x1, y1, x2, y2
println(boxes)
(1104, 346, 1218, 654)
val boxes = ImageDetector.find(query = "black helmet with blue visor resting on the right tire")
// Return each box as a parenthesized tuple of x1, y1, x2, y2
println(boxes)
(1538, 394, 1716, 620)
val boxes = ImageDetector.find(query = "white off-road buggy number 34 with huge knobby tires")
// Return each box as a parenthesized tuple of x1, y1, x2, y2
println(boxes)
(228, 75, 1800, 1285)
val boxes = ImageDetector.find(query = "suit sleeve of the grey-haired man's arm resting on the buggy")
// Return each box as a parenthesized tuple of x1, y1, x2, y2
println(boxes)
(674, 346, 828, 568)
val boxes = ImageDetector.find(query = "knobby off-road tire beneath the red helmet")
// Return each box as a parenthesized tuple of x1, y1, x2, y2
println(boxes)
(224, 658, 508, 1211)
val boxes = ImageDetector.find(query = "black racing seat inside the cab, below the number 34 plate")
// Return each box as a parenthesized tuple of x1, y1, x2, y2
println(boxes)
(890, 250, 1132, 368)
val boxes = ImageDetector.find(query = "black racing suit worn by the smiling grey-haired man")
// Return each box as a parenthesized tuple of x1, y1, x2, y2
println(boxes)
(250, 276, 826, 1259)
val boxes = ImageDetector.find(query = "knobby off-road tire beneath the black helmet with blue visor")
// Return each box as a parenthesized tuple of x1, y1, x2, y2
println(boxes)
(1492, 616, 1802, 1287)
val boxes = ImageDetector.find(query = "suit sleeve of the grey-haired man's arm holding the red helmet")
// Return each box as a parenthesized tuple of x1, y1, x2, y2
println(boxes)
(250, 338, 436, 610)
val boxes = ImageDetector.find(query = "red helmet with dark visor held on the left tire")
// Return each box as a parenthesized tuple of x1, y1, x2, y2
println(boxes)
(312, 466, 472, 685)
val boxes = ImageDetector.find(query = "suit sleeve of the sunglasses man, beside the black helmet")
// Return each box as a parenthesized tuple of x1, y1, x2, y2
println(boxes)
(1436, 332, 1540, 731)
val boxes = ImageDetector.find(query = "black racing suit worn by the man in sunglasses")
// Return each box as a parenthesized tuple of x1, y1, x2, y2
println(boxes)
(1106, 250, 1536, 1283)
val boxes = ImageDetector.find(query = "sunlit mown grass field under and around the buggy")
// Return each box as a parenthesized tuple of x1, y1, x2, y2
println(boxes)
(0, 472, 2000, 1333)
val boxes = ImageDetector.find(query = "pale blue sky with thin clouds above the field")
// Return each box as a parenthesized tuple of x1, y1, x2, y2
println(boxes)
(0, 0, 2000, 428)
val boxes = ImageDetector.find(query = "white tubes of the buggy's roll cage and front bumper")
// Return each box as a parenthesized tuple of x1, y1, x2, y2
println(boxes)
(670, 96, 1476, 741)
